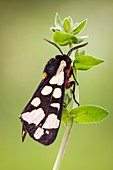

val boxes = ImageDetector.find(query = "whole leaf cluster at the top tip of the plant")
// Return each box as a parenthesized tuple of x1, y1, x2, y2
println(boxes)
(50, 13, 88, 46)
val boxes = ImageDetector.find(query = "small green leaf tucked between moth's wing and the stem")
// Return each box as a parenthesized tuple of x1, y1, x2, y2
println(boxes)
(62, 107, 69, 126)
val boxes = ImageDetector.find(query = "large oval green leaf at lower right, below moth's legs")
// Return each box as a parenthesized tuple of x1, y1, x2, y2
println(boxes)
(70, 106, 109, 123)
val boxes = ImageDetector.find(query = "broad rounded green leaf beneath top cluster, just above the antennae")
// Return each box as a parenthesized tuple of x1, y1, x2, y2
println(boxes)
(53, 31, 77, 46)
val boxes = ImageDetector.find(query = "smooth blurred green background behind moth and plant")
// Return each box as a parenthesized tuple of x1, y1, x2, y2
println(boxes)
(0, 0, 113, 170)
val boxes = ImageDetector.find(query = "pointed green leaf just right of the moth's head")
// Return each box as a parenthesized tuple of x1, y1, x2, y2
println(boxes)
(74, 55, 104, 70)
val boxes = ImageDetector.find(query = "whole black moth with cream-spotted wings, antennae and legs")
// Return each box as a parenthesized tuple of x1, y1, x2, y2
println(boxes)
(20, 39, 87, 145)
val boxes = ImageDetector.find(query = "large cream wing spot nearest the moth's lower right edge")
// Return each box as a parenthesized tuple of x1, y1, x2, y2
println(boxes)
(42, 114, 60, 129)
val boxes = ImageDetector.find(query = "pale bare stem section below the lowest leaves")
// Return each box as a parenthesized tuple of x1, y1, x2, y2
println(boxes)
(53, 117, 73, 170)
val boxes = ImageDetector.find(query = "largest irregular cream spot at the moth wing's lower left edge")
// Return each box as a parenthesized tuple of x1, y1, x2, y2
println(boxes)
(22, 108, 45, 125)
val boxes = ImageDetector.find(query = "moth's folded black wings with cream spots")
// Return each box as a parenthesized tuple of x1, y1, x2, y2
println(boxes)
(20, 57, 66, 145)
